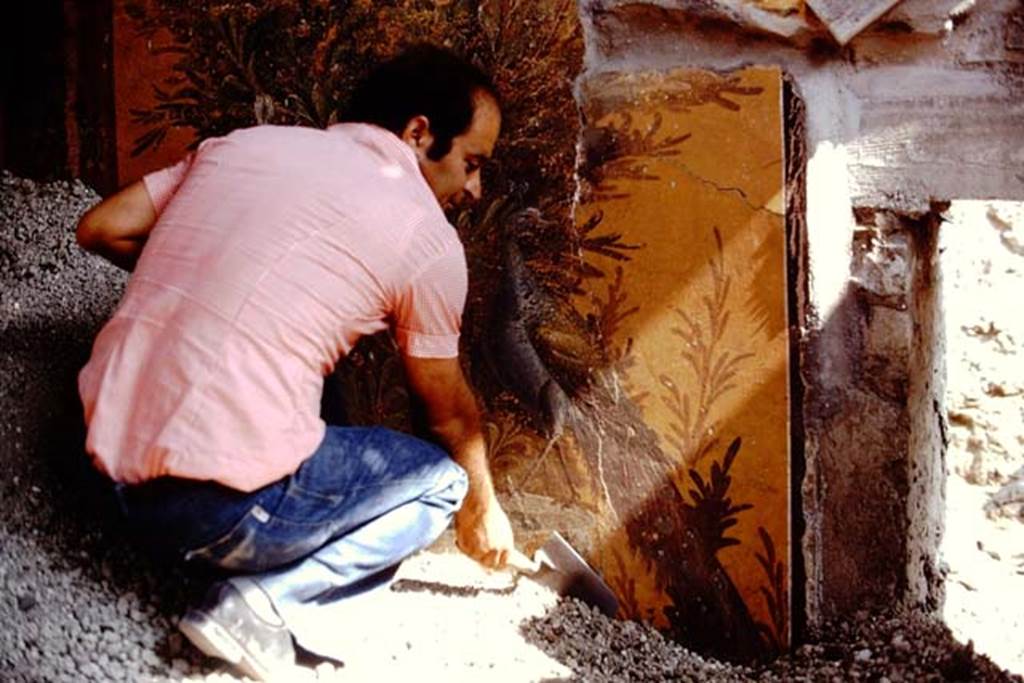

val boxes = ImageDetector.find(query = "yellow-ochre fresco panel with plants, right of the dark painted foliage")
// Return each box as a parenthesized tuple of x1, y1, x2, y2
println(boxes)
(577, 69, 790, 657)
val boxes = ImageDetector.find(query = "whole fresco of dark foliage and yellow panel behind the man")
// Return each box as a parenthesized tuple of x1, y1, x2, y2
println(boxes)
(115, 0, 790, 658)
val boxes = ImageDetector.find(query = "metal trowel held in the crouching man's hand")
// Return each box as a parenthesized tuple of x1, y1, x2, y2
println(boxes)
(507, 531, 618, 616)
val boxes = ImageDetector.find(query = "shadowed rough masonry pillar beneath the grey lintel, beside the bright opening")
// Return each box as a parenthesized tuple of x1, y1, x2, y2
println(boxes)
(802, 208, 945, 624)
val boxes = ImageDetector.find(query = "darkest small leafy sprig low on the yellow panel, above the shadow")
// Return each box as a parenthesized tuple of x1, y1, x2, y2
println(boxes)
(685, 436, 754, 553)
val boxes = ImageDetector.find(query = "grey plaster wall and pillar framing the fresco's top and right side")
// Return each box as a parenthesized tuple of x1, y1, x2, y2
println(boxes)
(581, 0, 1024, 628)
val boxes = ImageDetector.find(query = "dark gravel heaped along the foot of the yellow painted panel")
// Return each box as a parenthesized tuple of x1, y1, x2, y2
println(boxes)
(525, 600, 1021, 683)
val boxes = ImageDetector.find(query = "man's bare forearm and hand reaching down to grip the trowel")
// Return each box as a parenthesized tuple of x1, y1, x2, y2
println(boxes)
(406, 356, 513, 567)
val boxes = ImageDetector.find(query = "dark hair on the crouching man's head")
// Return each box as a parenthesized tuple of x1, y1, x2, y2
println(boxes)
(344, 44, 499, 161)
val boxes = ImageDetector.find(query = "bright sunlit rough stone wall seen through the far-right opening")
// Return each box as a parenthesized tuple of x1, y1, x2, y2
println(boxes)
(940, 200, 1024, 672)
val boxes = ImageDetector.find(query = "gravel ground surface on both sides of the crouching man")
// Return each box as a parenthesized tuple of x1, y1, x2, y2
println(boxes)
(0, 172, 1021, 682)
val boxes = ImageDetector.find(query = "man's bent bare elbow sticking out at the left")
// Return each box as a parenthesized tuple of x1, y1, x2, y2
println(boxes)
(75, 180, 157, 270)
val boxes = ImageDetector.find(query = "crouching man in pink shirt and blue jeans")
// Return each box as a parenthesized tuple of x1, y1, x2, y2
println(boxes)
(78, 46, 513, 679)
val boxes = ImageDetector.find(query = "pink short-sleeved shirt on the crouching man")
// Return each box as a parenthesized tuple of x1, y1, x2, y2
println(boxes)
(79, 124, 467, 490)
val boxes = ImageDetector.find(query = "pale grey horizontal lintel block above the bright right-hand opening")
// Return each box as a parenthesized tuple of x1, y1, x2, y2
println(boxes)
(848, 66, 1024, 212)
